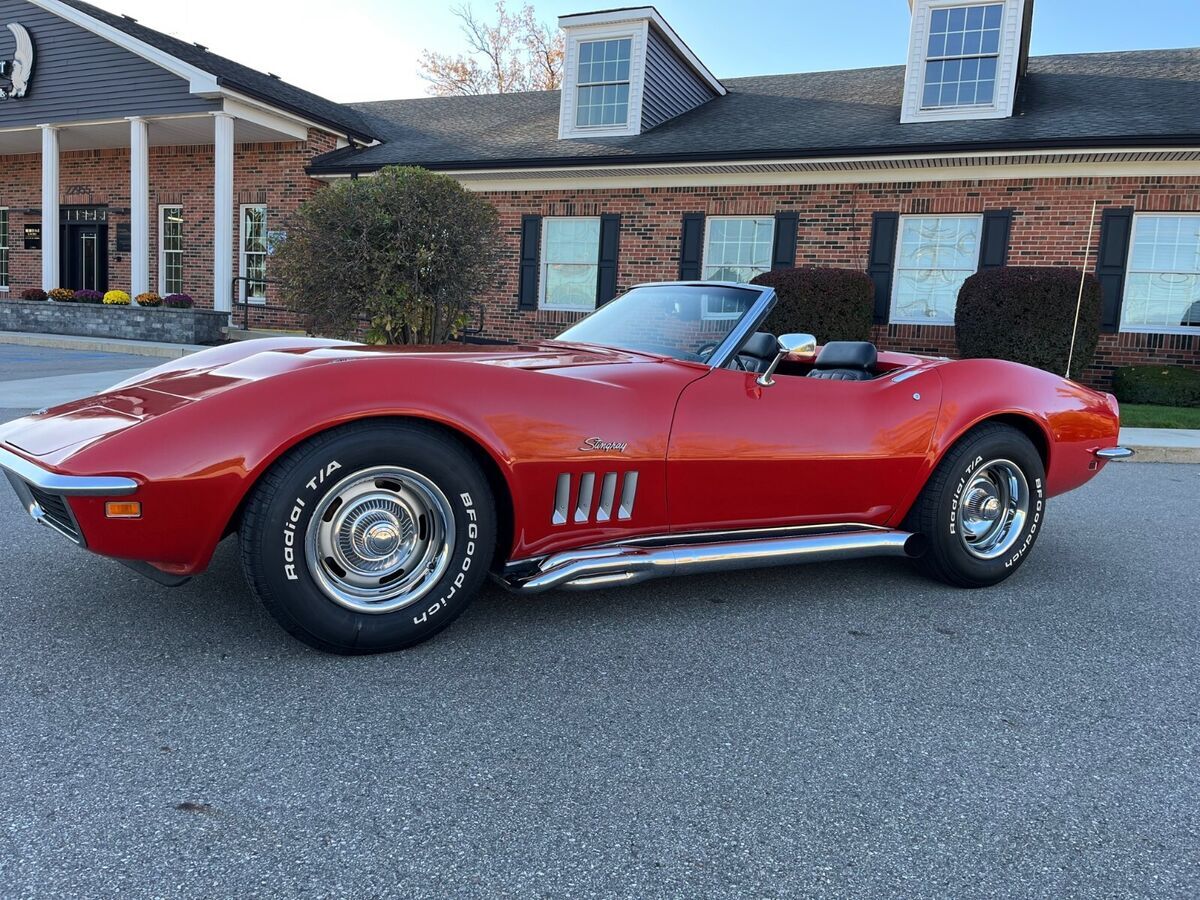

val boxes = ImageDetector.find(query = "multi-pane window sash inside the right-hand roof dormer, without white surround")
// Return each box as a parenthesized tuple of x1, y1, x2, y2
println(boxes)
(920, 4, 1004, 109)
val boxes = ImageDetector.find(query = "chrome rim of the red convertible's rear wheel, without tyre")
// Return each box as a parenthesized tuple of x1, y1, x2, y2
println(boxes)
(958, 460, 1030, 559)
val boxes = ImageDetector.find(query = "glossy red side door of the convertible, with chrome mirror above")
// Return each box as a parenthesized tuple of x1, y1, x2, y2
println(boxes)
(667, 370, 941, 530)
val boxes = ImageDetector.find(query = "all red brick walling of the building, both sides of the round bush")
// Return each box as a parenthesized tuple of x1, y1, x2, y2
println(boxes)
(0, 150, 1200, 385)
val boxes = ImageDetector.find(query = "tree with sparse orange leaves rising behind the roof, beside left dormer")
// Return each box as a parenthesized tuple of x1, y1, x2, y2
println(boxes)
(419, 0, 564, 97)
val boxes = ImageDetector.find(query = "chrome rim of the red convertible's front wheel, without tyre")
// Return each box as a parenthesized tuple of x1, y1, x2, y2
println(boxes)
(305, 466, 455, 613)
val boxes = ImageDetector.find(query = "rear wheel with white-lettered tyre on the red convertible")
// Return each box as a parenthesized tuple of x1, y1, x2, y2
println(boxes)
(905, 422, 1045, 588)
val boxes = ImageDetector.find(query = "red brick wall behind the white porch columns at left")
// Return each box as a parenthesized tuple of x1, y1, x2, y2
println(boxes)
(0, 130, 336, 328)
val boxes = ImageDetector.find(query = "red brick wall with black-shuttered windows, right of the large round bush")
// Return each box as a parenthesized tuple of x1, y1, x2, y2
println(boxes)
(472, 176, 1200, 385)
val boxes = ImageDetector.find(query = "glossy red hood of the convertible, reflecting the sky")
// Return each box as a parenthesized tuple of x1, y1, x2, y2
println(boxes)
(0, 338, 658, 457)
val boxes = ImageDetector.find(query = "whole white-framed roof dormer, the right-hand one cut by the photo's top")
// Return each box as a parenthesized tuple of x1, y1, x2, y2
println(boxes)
(900, 0, 1033, 124)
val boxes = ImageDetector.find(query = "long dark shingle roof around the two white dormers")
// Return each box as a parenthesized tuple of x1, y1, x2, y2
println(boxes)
(311, 48, 1200, 174)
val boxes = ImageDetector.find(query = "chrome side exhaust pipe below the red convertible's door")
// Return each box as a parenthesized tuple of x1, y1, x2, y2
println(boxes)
(508, 529, 923, 594)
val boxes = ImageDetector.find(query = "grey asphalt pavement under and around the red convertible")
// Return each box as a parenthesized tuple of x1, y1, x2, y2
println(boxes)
(0, 347, 1200, 899)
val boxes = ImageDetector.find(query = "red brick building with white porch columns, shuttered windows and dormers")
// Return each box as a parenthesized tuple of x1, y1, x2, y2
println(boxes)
(0, 0, 1200, 384)
